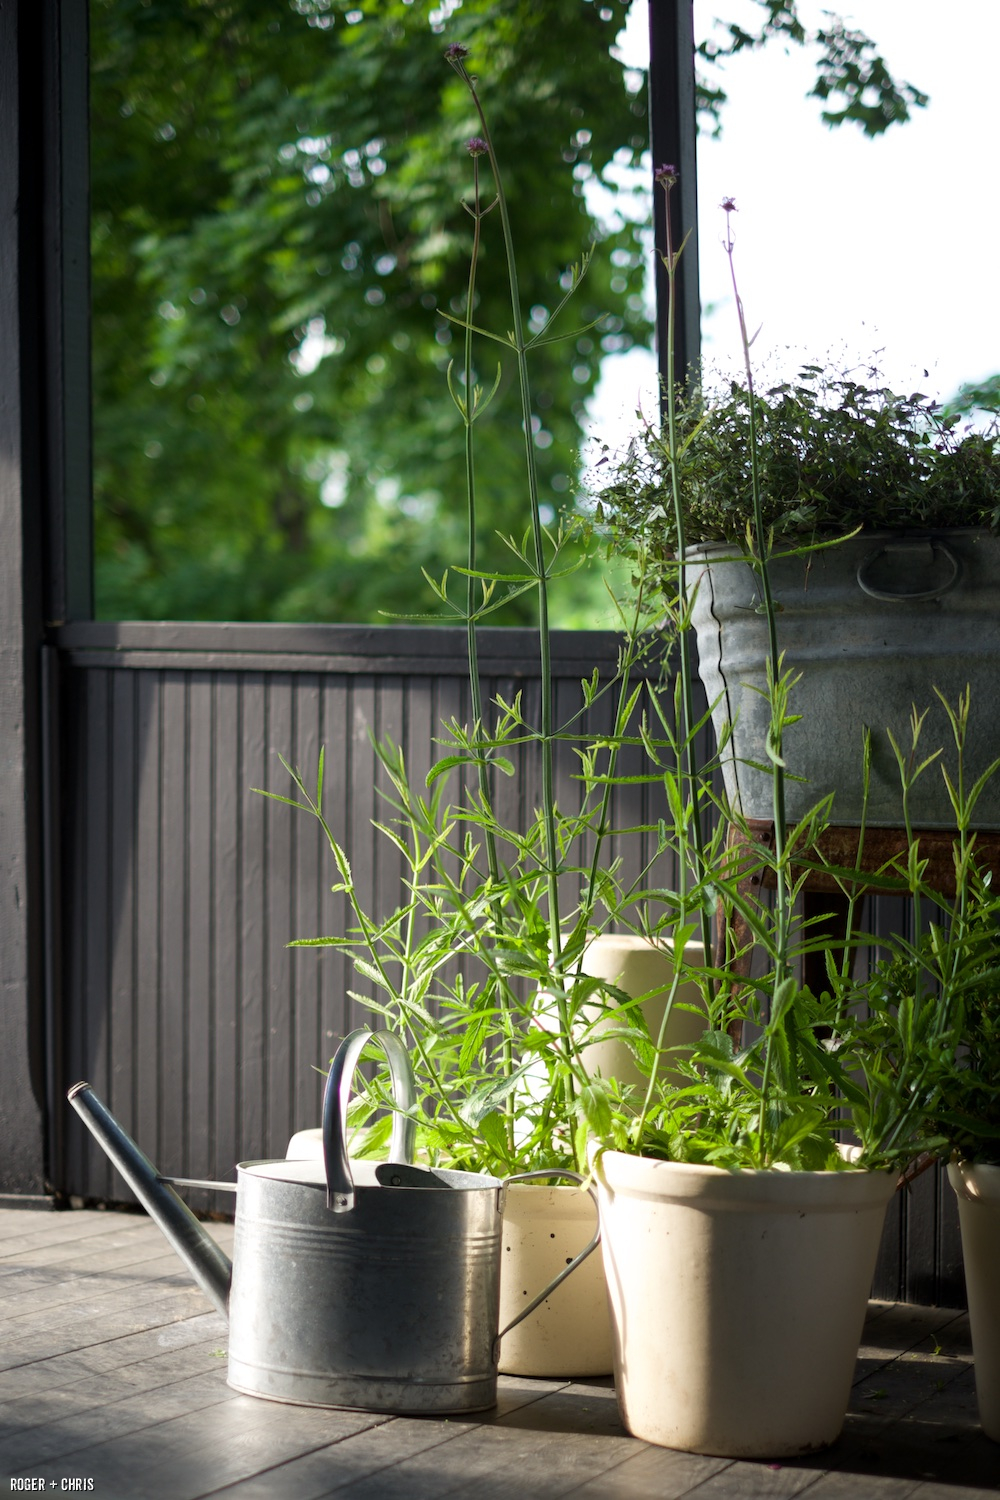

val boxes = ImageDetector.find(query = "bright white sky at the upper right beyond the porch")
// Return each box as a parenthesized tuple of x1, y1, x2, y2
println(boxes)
(591, 0, 1000, 443)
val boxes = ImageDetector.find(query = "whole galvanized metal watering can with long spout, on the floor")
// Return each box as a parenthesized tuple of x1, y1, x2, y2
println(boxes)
(69, 1028, 600, 1415)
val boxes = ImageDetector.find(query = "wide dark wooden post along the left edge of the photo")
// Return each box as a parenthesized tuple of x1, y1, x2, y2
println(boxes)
(0, 0, 90, 1206)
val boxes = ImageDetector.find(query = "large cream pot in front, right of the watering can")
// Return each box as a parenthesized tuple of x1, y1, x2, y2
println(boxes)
(595, 1152, 895, 1458)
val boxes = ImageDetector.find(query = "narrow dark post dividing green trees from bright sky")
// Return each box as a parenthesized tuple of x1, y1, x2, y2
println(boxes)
(649, 0, 702, 381)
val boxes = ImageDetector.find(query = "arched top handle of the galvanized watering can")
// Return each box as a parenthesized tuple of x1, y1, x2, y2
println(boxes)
(322, 1026, 417, 1214)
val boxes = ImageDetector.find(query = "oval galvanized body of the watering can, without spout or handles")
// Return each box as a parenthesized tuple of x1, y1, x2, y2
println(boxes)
(229, 1161, 504, 1416)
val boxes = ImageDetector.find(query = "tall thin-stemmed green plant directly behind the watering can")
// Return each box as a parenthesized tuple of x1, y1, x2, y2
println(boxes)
(265, 44, 668, 1173)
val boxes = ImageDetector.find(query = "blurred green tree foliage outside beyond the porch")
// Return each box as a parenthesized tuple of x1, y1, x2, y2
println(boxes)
(90, 0, 922, 624)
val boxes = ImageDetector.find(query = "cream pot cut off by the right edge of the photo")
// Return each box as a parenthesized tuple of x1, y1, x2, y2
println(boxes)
(948, 1161, 1000, 1443)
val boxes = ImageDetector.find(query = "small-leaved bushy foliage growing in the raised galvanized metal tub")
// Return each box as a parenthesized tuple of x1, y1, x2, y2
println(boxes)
(598, 366, 1000, 555)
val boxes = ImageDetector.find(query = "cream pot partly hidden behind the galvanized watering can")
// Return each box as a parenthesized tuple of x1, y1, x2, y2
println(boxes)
(499, 1182, 612, 1377)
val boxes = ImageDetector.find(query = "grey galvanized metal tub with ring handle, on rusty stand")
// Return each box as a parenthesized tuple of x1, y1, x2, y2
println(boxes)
(690, 528, 1000, 828)
